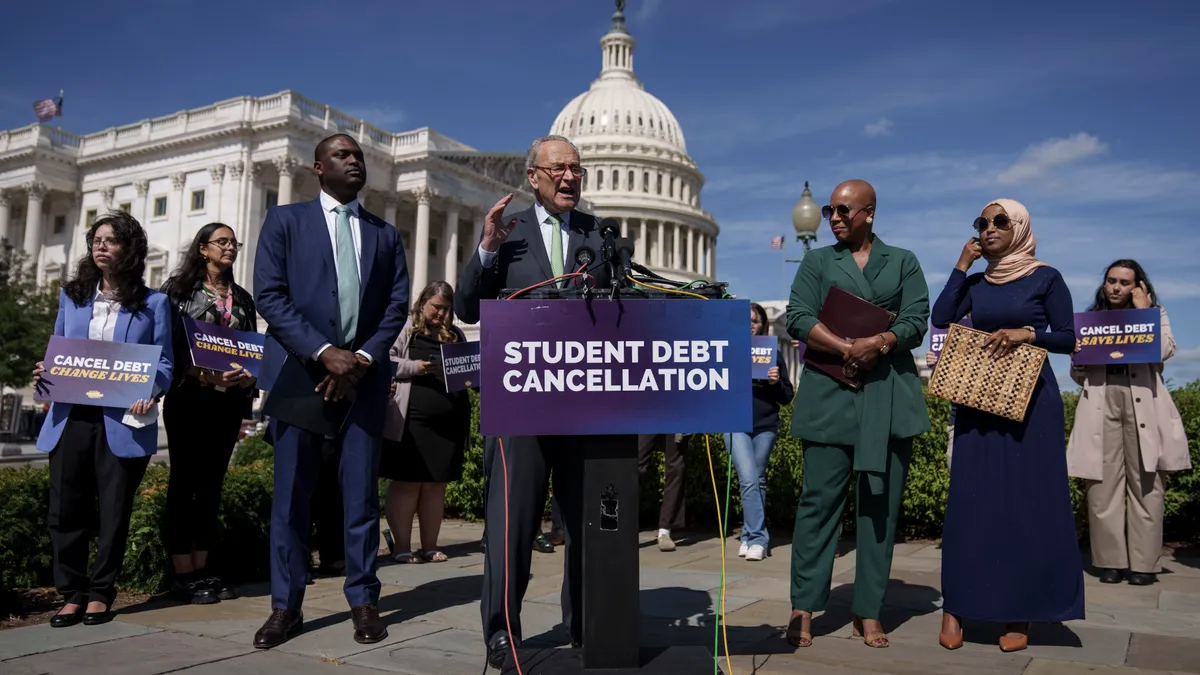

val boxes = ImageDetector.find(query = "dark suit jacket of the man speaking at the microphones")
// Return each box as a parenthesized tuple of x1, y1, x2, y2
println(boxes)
(454, 207, 612, 323)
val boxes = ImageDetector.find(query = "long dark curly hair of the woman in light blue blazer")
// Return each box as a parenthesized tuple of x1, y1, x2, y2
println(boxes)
(62, 211, 150, 312)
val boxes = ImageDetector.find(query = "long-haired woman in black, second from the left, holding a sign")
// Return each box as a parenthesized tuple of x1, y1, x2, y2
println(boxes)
(162, 222, 258, 604)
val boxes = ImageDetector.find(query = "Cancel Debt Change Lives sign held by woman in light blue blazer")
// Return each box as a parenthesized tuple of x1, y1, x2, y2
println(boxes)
(34, 335, 162, 408)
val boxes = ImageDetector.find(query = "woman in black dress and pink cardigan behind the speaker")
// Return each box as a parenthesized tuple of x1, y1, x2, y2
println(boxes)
(379, 281, 470, 563)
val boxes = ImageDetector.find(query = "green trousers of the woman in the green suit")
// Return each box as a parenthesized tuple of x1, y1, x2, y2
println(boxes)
(792, 438, 912, 619)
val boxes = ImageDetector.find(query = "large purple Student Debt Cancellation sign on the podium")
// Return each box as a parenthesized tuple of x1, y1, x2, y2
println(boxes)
(480, 298, 754, 436)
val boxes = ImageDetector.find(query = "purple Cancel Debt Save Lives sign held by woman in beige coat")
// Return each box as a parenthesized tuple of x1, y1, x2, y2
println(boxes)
(1070, 307, 1163, 365)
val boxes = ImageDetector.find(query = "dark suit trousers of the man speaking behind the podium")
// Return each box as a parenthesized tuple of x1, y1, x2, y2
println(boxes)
(480, 436, 585, 643)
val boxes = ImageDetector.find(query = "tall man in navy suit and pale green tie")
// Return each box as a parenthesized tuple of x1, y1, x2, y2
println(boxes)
(254, 133, 408, 649)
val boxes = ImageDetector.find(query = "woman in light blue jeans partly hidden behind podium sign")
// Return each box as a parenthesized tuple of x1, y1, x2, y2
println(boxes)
(725, 303, 796, 561)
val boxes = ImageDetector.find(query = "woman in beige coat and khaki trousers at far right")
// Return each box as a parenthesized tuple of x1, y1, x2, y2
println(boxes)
(1067, 261, 1192, 586)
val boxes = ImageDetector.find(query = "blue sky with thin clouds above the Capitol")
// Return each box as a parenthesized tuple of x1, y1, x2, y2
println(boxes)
(7, 0, 1200, 382)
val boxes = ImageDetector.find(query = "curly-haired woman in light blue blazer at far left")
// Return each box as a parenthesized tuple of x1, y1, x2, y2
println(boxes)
(34, 213, 172, 628)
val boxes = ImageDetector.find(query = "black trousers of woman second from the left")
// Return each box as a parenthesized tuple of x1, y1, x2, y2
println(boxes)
(163, 378, 246, 555)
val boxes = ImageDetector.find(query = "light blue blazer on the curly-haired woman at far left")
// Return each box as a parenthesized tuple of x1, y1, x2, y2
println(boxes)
(37, 285, 175, 458)
